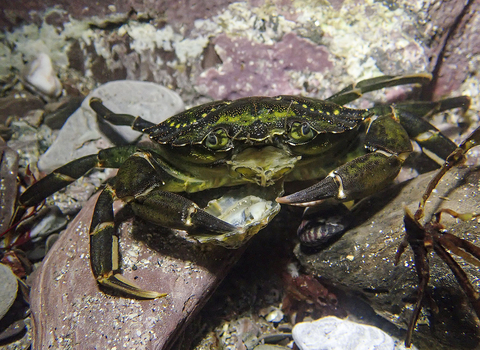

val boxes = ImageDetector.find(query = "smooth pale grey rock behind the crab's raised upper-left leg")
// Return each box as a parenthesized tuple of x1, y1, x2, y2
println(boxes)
(38, 80, 183, 172)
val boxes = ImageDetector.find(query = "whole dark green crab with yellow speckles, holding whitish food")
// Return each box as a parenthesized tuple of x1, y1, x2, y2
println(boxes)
(9, 74, 469, 298)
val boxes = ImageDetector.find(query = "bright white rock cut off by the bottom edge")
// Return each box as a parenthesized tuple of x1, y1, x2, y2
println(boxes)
(292, 316, 415, 350)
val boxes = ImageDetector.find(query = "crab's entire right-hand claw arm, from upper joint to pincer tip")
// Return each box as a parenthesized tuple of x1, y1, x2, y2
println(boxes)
(277, 115, 412, 207)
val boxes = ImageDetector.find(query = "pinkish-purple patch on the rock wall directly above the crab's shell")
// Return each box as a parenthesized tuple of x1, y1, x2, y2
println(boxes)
(197, 33, 333, 100)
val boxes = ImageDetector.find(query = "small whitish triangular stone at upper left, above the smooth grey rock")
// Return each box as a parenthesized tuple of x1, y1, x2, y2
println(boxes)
(25, 53, 62, 97)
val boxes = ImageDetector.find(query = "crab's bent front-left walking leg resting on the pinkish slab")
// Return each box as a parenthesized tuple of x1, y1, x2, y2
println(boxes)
(90, 185, 166, 299)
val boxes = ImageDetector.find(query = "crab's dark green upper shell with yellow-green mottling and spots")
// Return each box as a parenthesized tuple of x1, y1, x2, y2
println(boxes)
(148, 96, 371, 146)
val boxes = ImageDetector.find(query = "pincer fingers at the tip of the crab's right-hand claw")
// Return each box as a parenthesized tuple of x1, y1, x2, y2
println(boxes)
(276, 175, 341, 207)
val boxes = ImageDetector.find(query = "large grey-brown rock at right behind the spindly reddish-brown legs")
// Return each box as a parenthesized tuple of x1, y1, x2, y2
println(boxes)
(295, 167, 480, 349)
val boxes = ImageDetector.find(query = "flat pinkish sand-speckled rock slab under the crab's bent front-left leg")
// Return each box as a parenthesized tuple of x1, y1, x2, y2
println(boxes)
(30, 196, 242, 350)
